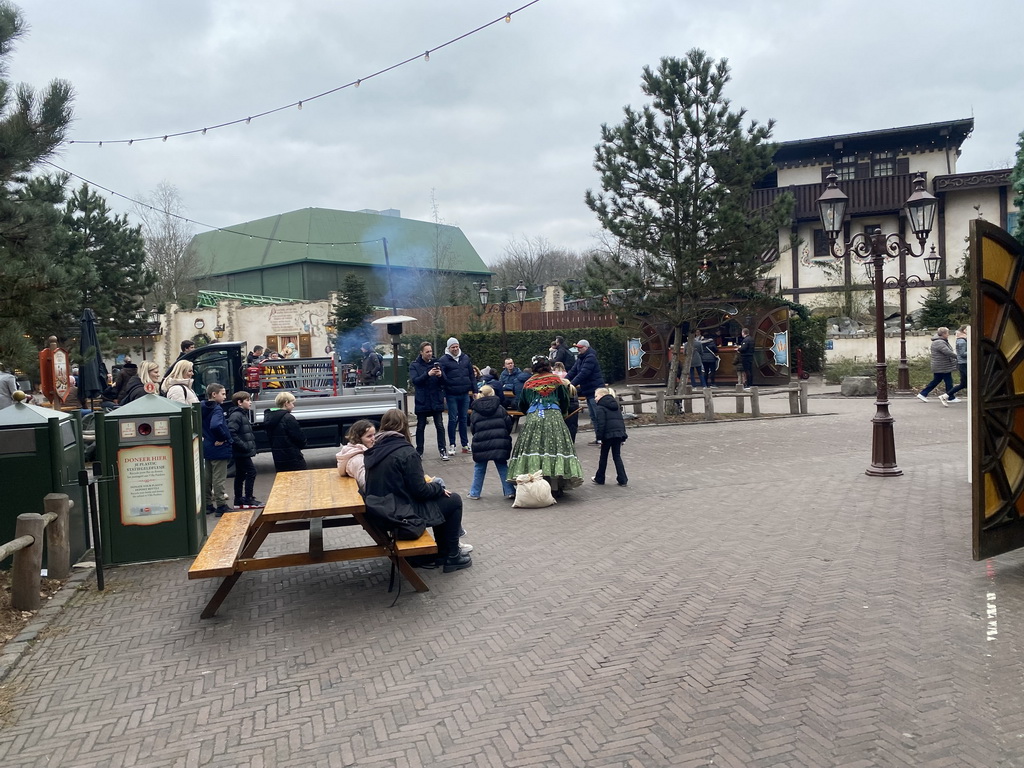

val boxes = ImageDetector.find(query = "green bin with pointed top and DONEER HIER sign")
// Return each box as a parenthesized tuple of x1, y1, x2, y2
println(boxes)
(96, 394, 207, 565)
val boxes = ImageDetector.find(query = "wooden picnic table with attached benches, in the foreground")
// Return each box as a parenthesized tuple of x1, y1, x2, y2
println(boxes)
(188, 468, 437, 618)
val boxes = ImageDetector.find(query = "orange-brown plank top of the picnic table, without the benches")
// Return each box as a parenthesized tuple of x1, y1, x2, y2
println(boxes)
(260, 467, 364, 521)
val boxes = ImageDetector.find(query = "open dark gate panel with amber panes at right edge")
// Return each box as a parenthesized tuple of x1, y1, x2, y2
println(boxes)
(969, 219, 1024, 560)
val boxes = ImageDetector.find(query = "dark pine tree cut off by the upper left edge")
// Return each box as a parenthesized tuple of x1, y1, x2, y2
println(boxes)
(0, 2, 74, 369)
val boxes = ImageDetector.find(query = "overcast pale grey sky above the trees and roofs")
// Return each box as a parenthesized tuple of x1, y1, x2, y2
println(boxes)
(9, 0, 1024, 262)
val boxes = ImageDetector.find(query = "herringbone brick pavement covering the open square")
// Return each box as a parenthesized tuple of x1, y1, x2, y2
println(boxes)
(0, 400, 1024, 768)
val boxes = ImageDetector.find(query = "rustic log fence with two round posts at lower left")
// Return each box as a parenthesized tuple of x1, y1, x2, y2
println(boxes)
(0, 494, 74, 610)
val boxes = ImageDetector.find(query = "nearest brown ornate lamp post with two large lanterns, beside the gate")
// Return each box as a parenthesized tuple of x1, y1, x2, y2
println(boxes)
(817, 171, 939, 477)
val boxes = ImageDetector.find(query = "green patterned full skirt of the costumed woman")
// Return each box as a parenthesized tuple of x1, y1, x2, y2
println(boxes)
(509, 410, 583, 492)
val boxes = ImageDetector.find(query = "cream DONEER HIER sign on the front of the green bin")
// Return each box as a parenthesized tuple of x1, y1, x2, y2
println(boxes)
(118, 445, 175, 525)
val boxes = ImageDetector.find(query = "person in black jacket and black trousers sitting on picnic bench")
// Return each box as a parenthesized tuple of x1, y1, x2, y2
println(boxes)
(364, 408, 473, 573)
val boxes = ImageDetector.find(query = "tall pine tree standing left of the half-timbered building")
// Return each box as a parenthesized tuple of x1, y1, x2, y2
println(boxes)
(586, 49, 793, 397)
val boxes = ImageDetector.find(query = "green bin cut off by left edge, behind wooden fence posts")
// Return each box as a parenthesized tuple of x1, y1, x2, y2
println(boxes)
(0, 402, 89, 567)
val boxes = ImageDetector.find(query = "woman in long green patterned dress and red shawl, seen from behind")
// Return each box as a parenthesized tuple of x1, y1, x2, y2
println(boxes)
(509, 357, 583, 496)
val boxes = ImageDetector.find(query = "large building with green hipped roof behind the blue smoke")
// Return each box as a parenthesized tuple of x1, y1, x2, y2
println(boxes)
(191, 208, 490, 305)
